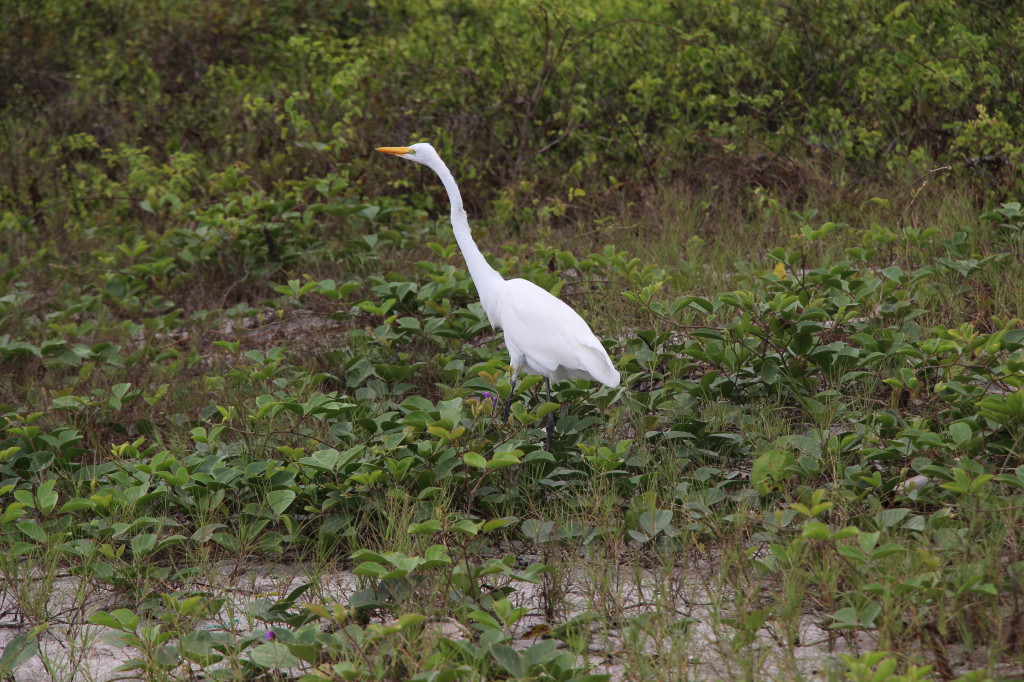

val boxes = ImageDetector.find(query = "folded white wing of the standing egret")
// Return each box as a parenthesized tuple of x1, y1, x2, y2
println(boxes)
(497, 280, 618, 386)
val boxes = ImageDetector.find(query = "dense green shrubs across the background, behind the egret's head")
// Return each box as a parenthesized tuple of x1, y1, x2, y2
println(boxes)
(0, 0, 1024, 220)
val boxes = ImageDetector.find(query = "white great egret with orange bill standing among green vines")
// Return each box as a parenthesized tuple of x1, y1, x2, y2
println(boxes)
(377, 142, 620, 450)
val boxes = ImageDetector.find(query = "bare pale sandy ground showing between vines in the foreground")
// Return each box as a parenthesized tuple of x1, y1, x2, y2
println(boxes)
(0, 557, 1007, 682)
